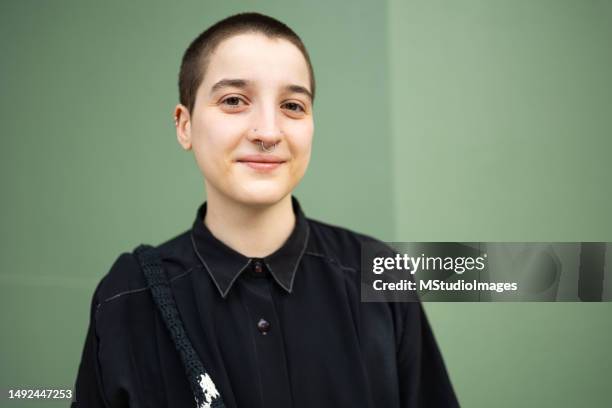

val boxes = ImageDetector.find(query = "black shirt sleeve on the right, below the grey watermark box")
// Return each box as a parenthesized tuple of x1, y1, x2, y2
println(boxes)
(397, 302, 459, 408)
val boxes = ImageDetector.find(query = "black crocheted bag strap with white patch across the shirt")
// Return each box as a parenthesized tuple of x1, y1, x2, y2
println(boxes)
(134, 244, 225, 408)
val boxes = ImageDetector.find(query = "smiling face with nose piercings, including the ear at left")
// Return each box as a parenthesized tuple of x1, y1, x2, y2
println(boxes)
(175, 33, 314, 205)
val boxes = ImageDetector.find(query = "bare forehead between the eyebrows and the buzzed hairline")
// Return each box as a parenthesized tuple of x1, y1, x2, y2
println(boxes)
(202, 33, 310, 89)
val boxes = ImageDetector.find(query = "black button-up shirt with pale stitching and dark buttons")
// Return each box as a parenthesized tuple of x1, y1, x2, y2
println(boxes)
(73, 196, 458, 408)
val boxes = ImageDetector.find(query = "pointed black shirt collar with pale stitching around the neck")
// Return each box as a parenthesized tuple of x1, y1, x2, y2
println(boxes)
(191, 195, 310, 298)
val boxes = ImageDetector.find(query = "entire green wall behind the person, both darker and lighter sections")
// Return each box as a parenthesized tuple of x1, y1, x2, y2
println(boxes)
(0, 0, 612, 407)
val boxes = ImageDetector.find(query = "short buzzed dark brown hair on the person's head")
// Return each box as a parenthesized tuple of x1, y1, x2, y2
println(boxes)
(178, 12, 315, 114)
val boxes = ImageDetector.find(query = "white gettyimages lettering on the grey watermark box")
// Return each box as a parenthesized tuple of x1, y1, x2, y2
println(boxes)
(372, 254, 487, 275)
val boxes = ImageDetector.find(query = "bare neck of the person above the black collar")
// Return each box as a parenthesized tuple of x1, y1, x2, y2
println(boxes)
(204, 190, 296, 258)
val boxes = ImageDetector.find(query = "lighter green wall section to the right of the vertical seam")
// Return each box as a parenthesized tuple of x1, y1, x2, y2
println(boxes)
(388, 0, 612, 407)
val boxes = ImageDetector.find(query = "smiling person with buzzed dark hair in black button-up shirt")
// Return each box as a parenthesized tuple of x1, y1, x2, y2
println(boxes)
(72, 13, 458, 408)
